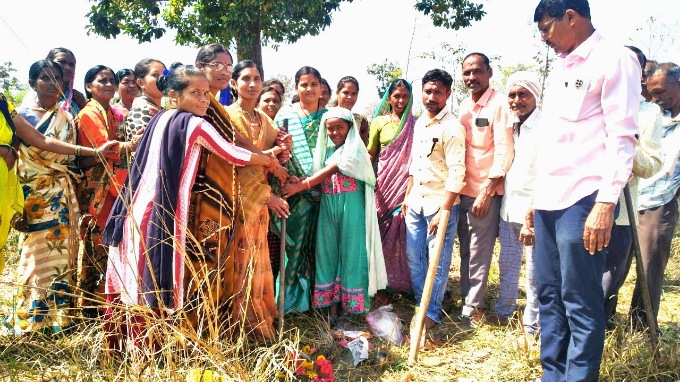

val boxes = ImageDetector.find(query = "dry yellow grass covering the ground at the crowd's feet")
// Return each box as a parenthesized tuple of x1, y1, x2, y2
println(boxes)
(0, 230, 680, 382)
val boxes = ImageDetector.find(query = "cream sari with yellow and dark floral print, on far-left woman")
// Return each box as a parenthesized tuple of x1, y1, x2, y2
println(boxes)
(6, 107, 80, 334)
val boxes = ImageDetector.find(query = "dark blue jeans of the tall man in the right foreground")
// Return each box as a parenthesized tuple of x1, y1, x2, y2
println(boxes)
(534, 193, 605, 382)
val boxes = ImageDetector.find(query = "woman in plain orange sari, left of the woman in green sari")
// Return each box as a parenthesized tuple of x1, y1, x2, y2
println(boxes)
(226, 60, 292, 340)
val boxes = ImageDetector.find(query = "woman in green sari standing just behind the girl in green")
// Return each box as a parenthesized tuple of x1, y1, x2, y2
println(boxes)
(272, 66, 326, 313)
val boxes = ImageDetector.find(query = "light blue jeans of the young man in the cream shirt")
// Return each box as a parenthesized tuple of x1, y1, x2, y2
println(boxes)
(406, 206, 460, 323)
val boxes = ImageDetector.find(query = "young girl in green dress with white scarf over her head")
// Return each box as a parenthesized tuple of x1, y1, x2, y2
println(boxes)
(282, 107, 387, 321)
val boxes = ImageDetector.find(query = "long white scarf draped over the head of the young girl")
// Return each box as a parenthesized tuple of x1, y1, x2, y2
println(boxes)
(313, 107, 387, 296)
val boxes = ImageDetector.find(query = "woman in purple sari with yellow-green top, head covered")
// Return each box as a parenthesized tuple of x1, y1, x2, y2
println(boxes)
(367, 79, 416, 292)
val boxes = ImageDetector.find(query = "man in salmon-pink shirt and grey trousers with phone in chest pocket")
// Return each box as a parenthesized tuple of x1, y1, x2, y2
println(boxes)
(458, 53, 514, 326)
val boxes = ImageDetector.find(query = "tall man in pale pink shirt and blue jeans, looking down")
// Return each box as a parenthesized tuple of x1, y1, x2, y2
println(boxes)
(527, 0, 641, 381)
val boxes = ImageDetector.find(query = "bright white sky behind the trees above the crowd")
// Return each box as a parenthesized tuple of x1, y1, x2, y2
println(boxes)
(0, 0, 680, 112)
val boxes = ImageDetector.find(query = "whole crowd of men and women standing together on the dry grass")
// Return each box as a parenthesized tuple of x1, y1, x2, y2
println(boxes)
(0, 0, 680, 381)
